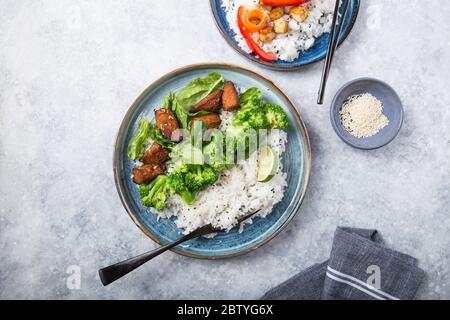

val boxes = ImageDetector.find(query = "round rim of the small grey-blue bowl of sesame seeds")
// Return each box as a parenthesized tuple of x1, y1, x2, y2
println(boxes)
(330, 77, 405, 151)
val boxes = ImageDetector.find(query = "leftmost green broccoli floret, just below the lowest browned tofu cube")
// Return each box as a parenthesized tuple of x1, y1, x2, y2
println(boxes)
(139, 175, 169, 211)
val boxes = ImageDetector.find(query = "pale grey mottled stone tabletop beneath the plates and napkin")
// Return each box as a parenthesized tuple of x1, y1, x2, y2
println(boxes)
(0, 0, 450, 299)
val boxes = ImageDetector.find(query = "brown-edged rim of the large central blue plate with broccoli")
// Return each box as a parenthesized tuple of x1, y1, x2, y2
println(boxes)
(113, 63, 312, 260)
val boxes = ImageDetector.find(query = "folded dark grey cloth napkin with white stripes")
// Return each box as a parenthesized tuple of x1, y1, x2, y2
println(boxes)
(262, 227, 425, 300)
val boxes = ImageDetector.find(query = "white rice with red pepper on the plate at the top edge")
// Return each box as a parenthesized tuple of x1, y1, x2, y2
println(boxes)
(222, 0, 336, 61)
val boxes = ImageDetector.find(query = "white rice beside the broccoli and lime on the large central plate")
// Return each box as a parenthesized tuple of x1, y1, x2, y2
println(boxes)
(158, 128, 287, 233)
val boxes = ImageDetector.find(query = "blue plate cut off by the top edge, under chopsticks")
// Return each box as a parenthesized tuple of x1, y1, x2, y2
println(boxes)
(210, 0, 360, 71)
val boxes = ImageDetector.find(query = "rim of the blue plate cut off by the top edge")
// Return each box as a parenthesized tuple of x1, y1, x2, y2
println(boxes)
(209, 0, 361, 71)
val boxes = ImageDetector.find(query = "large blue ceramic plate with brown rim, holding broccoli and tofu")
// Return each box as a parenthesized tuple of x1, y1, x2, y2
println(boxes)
(114, 64, 311, 259)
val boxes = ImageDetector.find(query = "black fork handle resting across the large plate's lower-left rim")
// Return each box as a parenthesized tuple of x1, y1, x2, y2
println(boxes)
(98, 232, 198, 286)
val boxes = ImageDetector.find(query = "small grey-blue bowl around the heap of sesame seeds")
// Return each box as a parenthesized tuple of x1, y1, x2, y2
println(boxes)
(330, 78, 404, 150)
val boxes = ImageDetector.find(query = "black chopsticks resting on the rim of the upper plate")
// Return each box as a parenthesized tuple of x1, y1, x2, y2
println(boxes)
(317, 0, 350, 104)
